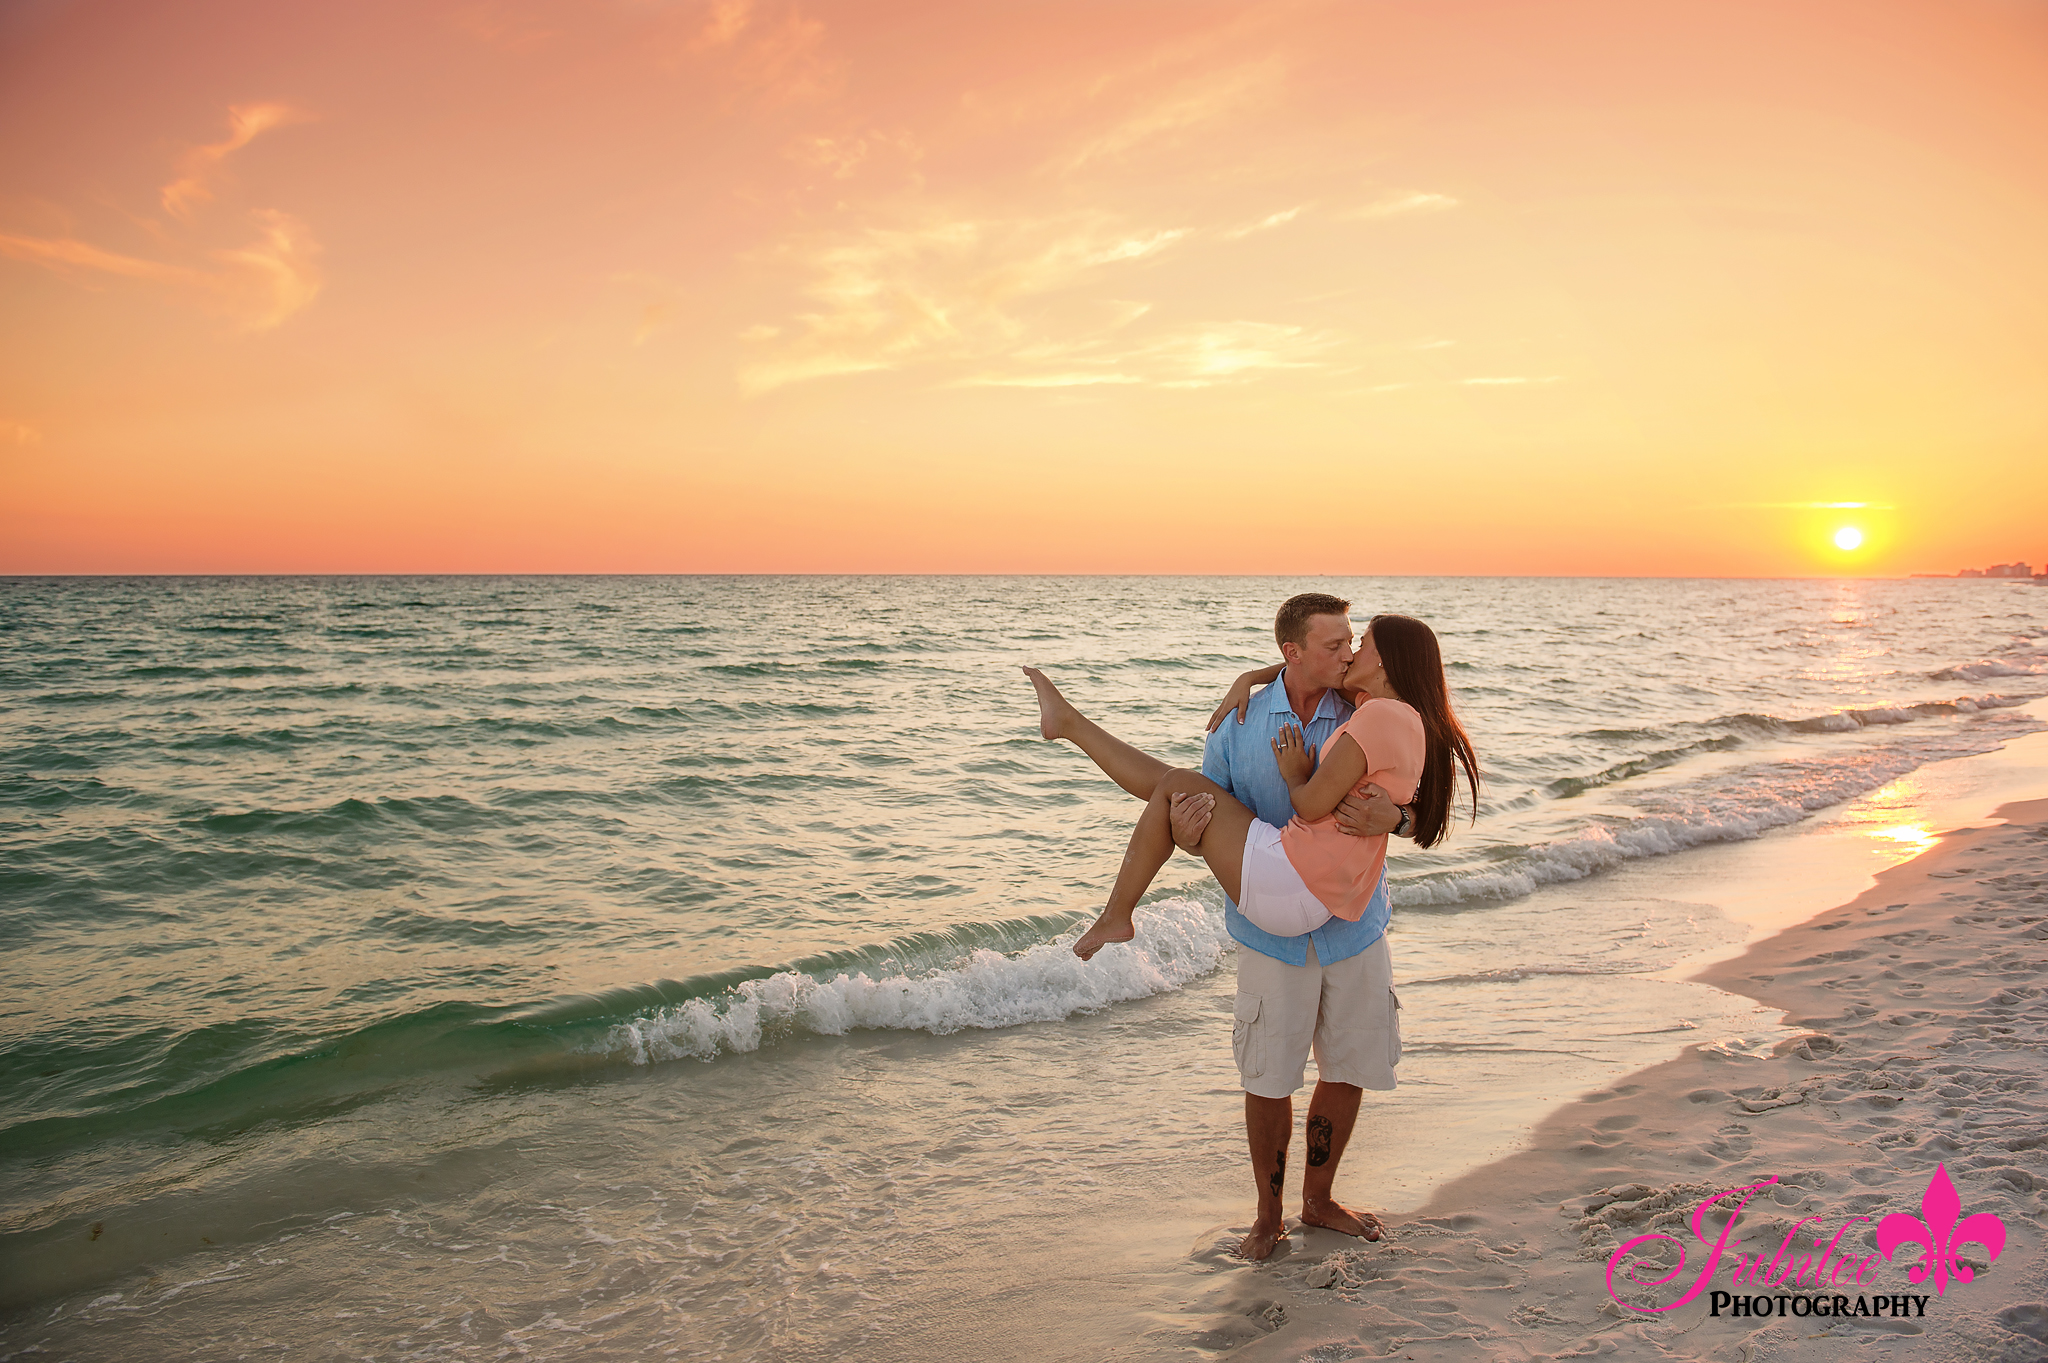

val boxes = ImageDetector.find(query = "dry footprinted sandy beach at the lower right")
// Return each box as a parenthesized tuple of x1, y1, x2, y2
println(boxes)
(1233, 798, 2048, 1363)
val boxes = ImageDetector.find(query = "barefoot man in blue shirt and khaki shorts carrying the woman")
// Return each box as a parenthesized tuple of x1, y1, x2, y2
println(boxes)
(1171, 591, 1413, 1259)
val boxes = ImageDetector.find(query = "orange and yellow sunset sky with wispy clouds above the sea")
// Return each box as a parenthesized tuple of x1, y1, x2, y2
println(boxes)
(0, 0, 2048, 577)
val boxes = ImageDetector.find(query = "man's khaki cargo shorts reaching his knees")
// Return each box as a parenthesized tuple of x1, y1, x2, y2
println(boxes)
(1231, 933, 1401, 1097)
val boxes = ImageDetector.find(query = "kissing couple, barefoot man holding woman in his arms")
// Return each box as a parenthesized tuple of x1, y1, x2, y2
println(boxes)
(1024, 591, 1479, 1259)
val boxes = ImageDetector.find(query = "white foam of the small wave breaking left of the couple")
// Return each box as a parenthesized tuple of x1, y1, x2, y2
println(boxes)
(596, 898, 1231, 1064)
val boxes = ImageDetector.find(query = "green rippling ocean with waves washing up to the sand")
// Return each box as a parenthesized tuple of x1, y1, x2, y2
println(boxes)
(0, 577, 2048, 1359)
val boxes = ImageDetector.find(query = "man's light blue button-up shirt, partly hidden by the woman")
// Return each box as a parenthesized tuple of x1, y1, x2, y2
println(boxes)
(1202, 673, 1391, 966)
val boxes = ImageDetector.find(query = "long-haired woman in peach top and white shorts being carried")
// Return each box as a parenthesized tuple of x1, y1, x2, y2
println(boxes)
(1024, 616, 1479, 960)
